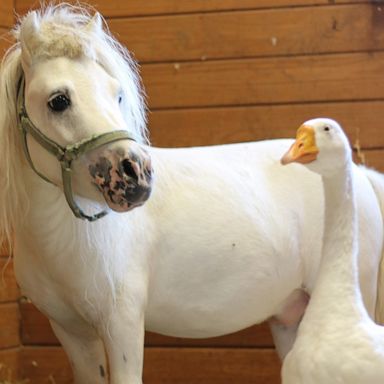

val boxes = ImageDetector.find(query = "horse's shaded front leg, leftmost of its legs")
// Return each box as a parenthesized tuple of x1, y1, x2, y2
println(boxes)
(50, 320, 108, 384)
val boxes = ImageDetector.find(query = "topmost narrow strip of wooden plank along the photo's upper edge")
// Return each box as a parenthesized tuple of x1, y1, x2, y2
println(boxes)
(15, 0, 370, 17)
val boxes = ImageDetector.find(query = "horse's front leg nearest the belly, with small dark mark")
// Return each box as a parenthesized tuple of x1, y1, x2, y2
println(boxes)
(103, 305, 144, 384)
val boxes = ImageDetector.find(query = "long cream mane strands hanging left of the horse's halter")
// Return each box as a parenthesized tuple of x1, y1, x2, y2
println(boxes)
(0, 44, 28, 252)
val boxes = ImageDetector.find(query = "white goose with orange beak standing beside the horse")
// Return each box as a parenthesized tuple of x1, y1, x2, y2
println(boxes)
(281, 119, 384, 384)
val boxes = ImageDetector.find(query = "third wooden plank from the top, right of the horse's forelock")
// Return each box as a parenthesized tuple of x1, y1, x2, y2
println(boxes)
(142, 52, 384, 109)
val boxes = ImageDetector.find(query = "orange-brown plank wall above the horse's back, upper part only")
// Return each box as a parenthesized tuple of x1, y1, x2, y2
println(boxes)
(16, 0, 384, 167)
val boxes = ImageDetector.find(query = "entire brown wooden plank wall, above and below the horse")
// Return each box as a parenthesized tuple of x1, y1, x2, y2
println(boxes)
(9, 0, 384, 384)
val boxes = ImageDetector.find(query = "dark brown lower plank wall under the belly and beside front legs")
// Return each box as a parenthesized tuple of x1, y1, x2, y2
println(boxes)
(21, 302, 279, 384)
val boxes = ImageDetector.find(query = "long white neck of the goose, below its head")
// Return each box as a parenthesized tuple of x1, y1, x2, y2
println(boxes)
(308, 165, 366, 318)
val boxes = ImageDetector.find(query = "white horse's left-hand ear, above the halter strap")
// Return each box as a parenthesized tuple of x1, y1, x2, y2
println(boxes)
(19, 12, 39, 70)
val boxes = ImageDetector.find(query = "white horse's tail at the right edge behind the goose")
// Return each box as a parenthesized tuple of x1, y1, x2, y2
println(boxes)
(363, 167, 384, 325)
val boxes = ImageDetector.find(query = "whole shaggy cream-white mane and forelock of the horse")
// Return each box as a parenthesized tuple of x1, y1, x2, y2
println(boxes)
(0, 4, 149, 249)
